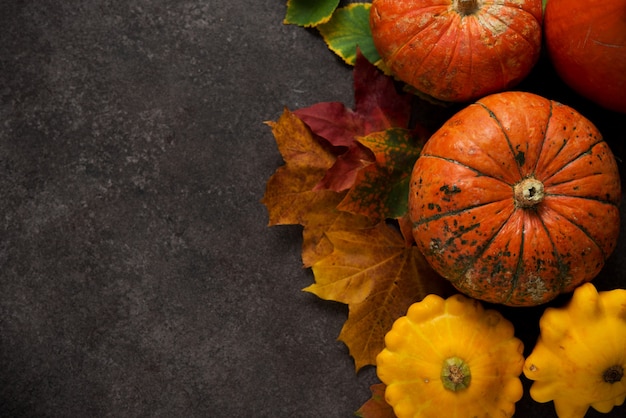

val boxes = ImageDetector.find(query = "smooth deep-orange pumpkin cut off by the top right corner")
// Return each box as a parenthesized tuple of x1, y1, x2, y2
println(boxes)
(544, 0, 626, 113)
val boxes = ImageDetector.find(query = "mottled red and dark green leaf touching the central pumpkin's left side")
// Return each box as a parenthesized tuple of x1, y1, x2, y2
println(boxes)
(338, 128, 426, 220)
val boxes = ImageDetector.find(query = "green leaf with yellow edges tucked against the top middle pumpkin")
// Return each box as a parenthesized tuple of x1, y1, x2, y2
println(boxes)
(317, 3, 382, 67)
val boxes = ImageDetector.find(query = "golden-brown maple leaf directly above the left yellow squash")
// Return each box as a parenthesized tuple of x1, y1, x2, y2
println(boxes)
(304, 222, 449, 370)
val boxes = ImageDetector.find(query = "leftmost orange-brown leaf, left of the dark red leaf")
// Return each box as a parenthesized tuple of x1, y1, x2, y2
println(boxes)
(261, 109, 343, 225)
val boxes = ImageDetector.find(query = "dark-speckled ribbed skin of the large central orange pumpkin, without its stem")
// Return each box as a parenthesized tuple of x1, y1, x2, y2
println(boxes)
(409, 92, 621, 306)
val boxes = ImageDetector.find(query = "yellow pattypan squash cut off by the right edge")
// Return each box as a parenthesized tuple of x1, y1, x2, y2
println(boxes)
(524, 283, 626, 418)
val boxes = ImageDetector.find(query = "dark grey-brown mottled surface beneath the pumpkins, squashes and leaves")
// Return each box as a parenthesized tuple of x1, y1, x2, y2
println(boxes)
(0, 0, 626, 418)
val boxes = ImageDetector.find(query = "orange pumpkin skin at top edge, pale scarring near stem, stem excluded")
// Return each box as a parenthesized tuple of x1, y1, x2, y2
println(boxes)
(370, 0, 542, 102)
